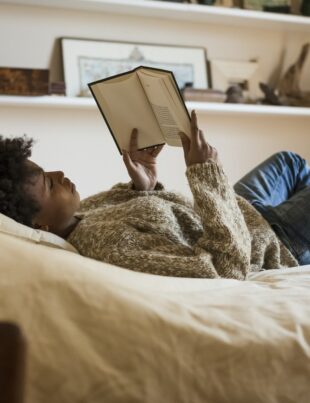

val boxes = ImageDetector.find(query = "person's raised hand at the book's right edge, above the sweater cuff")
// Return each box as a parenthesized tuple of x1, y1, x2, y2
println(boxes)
(180, 110, 219, 167)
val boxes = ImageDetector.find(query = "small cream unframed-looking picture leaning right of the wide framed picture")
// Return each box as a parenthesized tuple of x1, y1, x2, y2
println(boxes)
(209, 59, 261, 99)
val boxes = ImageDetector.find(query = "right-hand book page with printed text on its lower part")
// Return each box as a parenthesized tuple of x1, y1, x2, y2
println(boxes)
(137, 68, 190, 146)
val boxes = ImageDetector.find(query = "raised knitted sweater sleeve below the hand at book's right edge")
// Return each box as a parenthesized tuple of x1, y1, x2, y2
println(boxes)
(186, 161, 251, 278)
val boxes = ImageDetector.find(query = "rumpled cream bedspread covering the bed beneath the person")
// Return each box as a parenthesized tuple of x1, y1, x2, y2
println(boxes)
(0, 230, 310, 403)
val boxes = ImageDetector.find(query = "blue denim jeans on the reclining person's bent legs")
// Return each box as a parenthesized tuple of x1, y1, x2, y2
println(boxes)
(234, 152, 310, 265)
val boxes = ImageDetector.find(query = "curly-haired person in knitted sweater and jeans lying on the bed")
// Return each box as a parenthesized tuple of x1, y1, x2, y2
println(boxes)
(0, 111, 310, 279)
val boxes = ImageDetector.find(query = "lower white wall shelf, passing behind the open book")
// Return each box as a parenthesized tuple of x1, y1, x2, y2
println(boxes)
(0, 95, 310, 118)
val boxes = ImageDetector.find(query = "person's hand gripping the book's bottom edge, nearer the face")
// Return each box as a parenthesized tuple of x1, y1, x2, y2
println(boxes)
(122, 129, 163, 190)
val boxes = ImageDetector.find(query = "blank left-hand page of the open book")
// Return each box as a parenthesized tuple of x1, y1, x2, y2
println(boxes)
(91, 72, 165, 150)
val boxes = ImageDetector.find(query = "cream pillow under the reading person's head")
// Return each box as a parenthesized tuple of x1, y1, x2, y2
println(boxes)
(0, 213, 78, 253)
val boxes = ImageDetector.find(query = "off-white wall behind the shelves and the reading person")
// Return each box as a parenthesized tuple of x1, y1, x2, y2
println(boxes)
(0, 5, 310, 196)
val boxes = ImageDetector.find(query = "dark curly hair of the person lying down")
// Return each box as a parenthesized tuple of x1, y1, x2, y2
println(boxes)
(0, 135, 40, 227)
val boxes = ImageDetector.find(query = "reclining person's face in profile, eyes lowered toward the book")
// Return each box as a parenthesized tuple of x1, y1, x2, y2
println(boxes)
(26, 160, 80, 235)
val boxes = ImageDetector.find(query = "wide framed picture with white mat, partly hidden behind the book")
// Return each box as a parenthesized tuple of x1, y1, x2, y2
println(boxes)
(61, 38, 209, 97)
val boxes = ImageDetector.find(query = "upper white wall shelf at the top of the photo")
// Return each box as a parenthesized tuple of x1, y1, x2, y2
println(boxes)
(0, 0, 310, 32)
